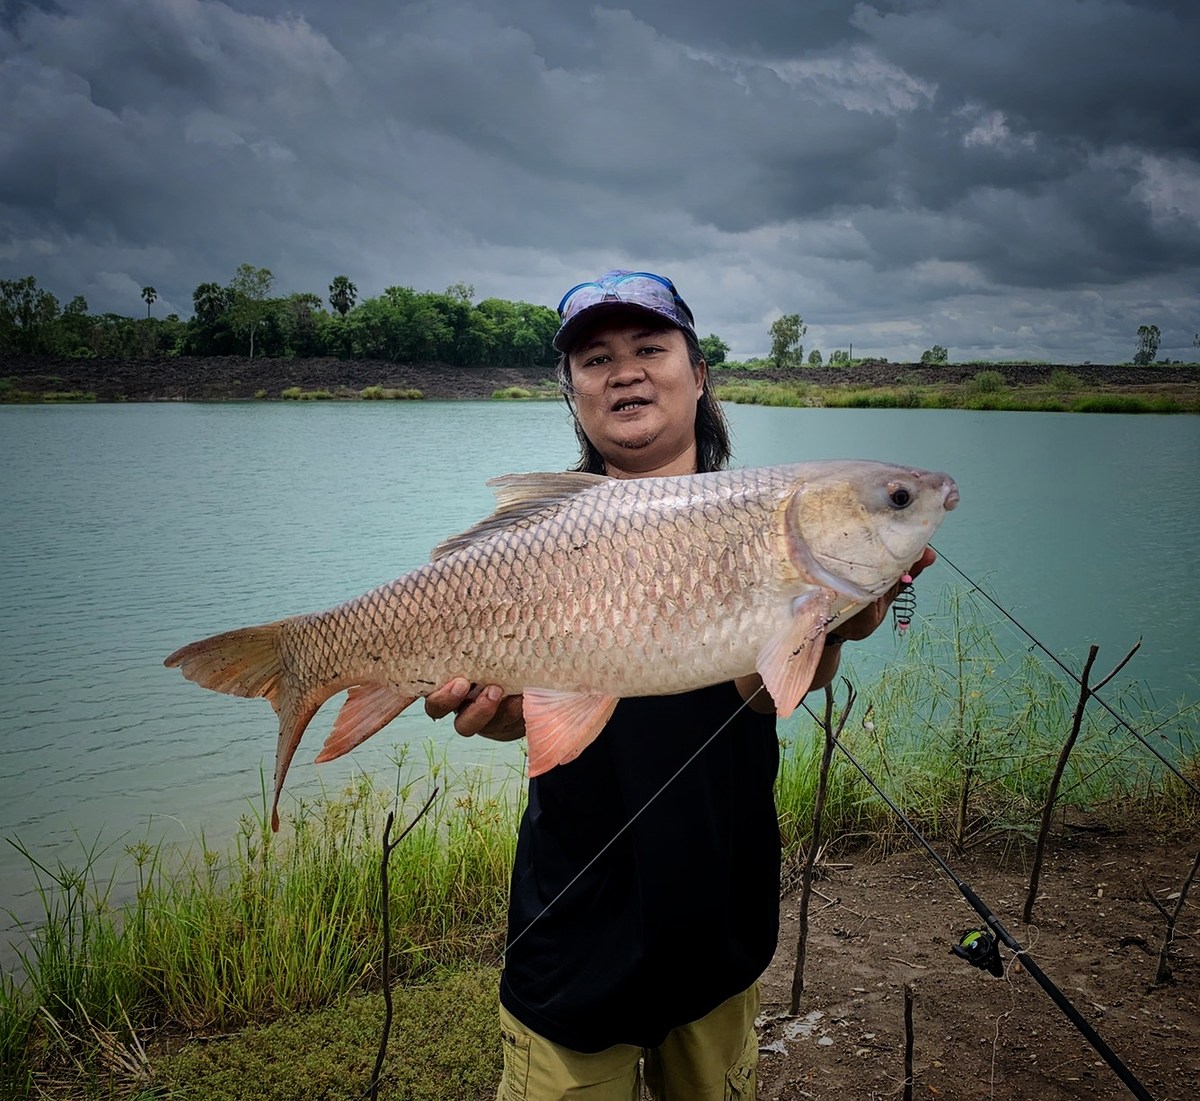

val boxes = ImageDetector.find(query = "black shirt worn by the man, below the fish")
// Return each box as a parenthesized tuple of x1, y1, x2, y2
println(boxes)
(500, 684, 780, 1052)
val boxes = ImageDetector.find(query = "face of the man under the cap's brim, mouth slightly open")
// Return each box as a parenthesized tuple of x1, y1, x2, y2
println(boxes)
(568, 315, 704, 477)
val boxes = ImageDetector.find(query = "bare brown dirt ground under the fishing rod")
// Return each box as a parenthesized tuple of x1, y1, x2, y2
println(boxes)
(760, 819, 1200, 1101)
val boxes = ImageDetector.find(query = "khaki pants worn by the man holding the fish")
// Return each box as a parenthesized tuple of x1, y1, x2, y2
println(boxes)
(496, 985, 758, 1101)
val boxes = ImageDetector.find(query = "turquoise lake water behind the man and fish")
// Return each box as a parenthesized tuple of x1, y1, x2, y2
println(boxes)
(0, 403, 1200, 962)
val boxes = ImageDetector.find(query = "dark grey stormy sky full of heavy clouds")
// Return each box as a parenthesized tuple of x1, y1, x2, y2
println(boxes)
(0, 0, 1200, 363)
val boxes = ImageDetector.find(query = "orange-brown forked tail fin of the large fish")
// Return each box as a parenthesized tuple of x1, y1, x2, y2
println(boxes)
(163, 620, 328, 830)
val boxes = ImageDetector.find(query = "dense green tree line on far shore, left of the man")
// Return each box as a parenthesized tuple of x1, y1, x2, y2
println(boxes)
(0, 264, 558, 367)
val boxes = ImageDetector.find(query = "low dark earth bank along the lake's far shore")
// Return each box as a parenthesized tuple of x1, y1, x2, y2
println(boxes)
(0, 356, 1200, 402)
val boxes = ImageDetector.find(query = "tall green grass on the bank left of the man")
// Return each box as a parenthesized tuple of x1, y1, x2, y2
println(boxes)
(0, 748, 521, 1096)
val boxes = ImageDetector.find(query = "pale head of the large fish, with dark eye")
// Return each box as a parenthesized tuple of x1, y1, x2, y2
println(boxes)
(786, 461, 959, 602)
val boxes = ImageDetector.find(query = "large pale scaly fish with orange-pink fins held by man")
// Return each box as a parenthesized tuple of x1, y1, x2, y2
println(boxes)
(166, 461, 959, 828)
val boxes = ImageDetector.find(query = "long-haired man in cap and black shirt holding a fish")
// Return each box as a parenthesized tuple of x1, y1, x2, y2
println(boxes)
(425, 271, 934, 1101)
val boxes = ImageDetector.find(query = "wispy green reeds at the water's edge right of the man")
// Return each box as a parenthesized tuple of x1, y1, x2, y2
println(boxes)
(776, 590, 1200, 853)
